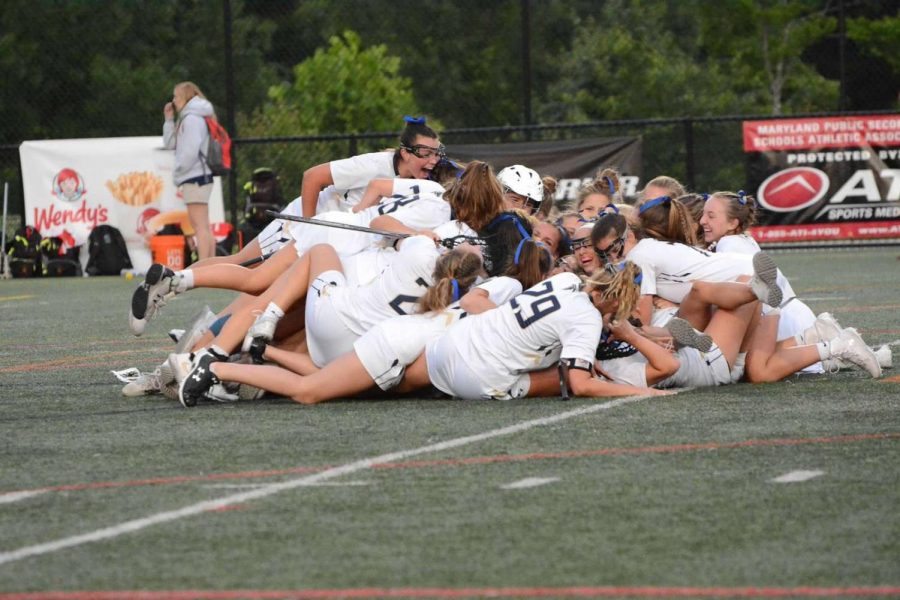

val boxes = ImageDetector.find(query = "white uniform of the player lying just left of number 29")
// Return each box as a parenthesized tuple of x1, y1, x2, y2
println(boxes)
(353, 277, 522, 389)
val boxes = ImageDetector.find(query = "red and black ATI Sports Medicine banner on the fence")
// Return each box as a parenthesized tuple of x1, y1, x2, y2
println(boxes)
(744, 115, 900, 243)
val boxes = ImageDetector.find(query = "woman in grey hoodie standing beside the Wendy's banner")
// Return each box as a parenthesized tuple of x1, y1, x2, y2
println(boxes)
(163, 81, 216, 260)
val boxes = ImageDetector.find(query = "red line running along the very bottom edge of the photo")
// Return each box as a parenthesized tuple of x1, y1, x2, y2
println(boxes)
(0, 586, 900, 600)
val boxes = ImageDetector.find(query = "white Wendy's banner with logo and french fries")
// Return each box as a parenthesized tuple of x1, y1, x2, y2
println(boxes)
(19, 136, 224, 271)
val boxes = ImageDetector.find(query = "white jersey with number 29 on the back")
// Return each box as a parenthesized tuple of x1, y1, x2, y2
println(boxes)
(431, 273, 603, 390)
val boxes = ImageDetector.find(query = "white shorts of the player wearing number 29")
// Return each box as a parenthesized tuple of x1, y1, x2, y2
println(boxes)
(425, 336, 531, 400)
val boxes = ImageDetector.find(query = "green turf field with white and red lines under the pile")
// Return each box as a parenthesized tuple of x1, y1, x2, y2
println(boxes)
(0, 249, 900, 600)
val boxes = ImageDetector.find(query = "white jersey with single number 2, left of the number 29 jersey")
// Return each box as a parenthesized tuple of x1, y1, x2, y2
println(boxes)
(329, 235, 440, 335)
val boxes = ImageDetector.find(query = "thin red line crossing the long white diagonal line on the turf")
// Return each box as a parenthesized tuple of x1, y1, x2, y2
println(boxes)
(0, 432, 900, 496)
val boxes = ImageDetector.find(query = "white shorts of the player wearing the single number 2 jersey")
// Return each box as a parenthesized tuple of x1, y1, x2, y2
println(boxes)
(306, 271, 359, 367)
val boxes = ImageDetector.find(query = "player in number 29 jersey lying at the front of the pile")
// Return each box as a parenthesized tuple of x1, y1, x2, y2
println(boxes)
(420, 269, 659, 399)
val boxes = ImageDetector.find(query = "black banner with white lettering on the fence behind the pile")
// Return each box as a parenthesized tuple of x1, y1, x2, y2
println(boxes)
(449, 137, 641, 202)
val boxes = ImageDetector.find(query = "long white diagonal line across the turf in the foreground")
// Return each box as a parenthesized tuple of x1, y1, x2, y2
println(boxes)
(0, 396, 649, 565)
